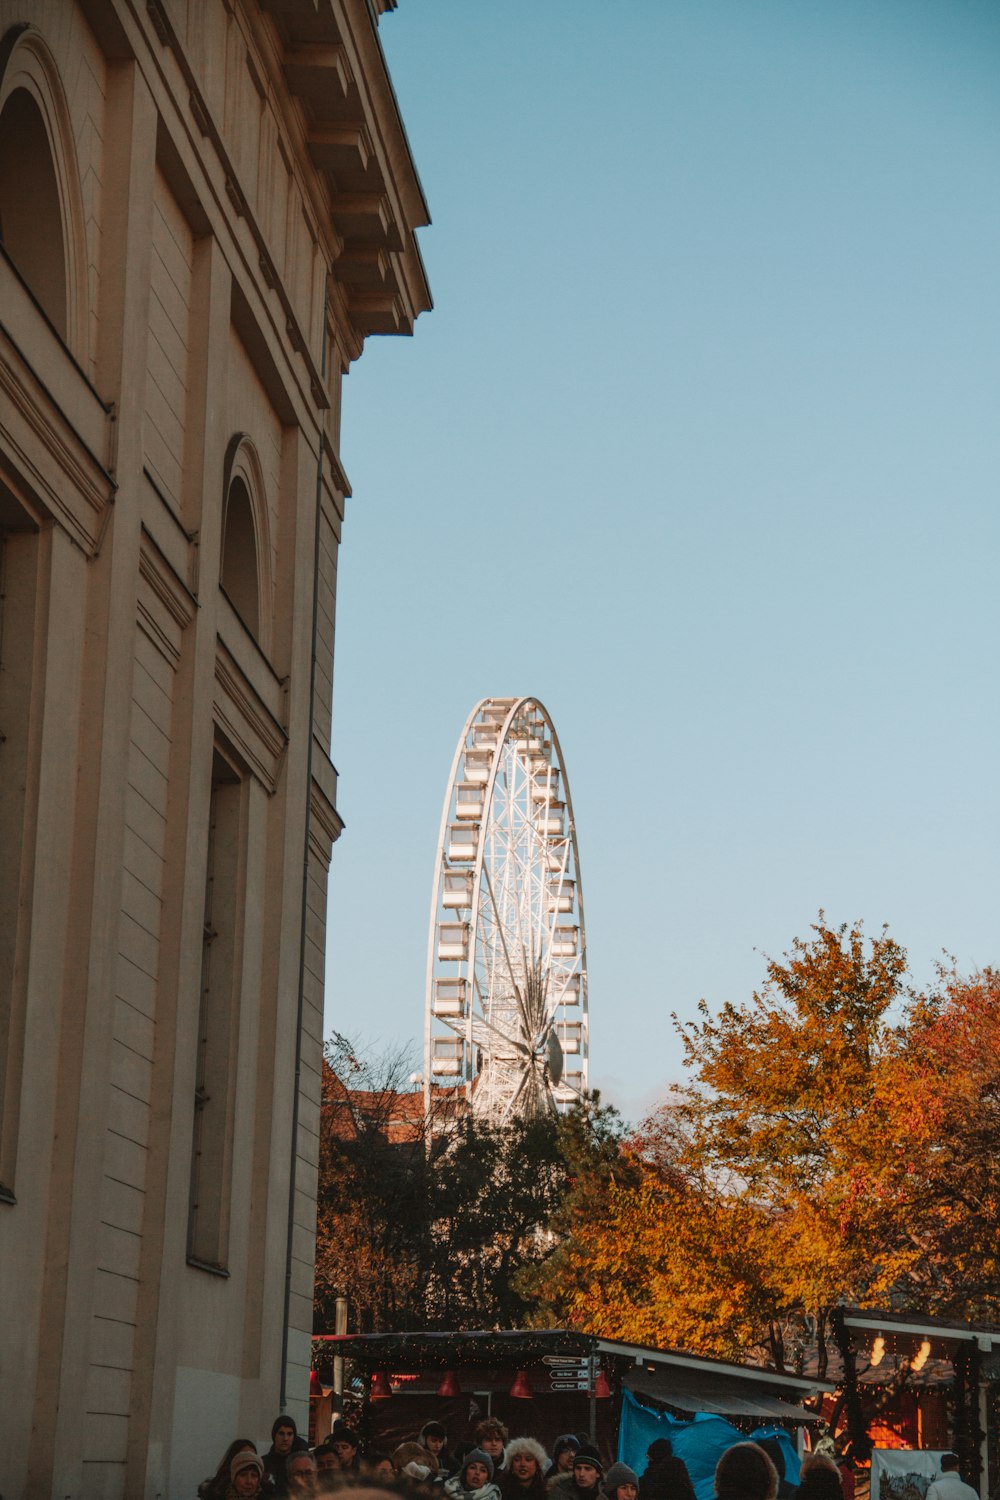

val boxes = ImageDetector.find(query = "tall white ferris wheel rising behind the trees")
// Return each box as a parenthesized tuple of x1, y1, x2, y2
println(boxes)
(423, 698, 588, 1124)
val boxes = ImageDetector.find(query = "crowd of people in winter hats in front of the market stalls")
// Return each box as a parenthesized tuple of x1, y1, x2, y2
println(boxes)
(198, 1416, 869, 1500)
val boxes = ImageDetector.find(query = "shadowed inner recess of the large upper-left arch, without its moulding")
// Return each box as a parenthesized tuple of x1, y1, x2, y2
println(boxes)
(0, 89, 69, 339)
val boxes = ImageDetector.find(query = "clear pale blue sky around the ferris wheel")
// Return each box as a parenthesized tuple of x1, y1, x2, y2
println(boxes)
(327, 0, 1000, 1118)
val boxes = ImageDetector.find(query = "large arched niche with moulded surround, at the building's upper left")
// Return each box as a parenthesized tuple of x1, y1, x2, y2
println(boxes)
(0, 26, 87, 362)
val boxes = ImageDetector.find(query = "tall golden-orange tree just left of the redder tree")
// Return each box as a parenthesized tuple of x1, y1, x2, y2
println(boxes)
(676, 914, 907, 1364)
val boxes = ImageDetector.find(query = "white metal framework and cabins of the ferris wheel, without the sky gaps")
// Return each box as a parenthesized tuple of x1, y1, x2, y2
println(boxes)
(423, 698, 589, 1124)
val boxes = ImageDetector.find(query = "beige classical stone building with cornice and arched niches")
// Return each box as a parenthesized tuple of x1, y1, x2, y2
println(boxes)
(0, 0, 430, 1500)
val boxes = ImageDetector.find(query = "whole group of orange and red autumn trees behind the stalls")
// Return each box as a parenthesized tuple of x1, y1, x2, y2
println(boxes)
(531, 914, 1000, 1368)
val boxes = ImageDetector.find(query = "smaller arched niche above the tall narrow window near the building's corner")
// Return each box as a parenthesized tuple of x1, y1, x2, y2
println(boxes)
(219, 432, 271, 651)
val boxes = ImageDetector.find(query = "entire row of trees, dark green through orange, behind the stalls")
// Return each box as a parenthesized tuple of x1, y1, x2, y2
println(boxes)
(318, 914, 1000, 1370)
